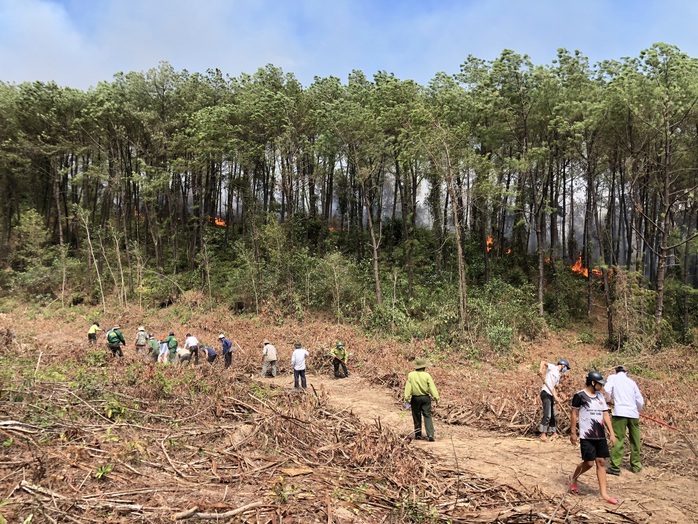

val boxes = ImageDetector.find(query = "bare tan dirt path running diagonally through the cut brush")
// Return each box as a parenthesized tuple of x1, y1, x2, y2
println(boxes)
(264, 374, 698, 523)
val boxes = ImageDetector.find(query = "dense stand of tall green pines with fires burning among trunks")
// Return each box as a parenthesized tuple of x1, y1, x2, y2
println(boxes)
(0, 44, 698, 351)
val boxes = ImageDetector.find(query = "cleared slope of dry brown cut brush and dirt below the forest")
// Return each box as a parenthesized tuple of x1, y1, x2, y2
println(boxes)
(0, 305, 698, 523)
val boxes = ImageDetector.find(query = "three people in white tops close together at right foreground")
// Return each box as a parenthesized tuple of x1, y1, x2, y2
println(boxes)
(538, 359, 645, 504)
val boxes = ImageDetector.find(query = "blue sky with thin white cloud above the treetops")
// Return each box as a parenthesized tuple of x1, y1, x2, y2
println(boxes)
(0, 0, 698, 90)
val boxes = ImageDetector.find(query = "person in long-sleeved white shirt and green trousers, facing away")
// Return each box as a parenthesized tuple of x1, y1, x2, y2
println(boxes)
(604, 366, 645, 475)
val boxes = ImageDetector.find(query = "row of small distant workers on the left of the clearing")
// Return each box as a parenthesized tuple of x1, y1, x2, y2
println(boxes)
(87, 322, 233, 368)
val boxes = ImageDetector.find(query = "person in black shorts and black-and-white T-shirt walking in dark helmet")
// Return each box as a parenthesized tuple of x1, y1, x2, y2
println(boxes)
(570, 371, 618, 504)
